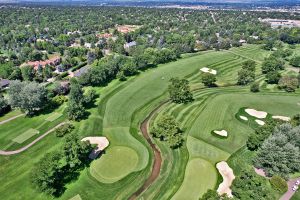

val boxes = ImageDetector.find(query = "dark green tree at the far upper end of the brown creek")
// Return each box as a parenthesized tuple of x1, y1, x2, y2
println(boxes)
(168, 78, 194, 104)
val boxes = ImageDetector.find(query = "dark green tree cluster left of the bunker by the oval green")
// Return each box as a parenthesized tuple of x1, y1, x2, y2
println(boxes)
(31, 133, 92, 197)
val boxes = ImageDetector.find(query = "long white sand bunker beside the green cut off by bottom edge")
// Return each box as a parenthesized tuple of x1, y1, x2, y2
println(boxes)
(217, 161, 235, 197)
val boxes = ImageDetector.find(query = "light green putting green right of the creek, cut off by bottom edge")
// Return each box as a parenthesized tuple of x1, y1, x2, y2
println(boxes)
(172, 158, 218, 200)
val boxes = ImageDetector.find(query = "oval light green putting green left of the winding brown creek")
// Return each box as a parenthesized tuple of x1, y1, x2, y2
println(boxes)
(90, 146, 139, 183)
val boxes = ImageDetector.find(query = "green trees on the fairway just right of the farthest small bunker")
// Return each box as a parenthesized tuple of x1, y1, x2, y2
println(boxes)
(237, 60, 256, 85)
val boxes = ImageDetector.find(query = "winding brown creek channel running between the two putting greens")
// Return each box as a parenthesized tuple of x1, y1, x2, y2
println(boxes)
(129, 101, 168, 200)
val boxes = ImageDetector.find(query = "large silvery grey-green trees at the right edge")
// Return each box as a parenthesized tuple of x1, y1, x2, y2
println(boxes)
(254, 123, 300, 178)
